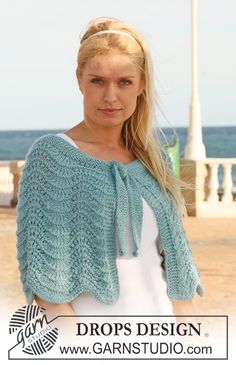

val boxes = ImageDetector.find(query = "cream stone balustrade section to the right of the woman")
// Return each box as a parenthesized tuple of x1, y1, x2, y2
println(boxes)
(181, 158, 236, 217)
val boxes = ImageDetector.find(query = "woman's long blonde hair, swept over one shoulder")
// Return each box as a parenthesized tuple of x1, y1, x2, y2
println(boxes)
(76, 18, 187, 215)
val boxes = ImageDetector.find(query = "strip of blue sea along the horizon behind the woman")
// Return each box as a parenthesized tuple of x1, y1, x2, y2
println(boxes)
(0, 126, 236, 186)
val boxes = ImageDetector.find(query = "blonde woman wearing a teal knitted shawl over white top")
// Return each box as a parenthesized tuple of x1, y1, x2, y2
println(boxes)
(17, 18, 203, 315)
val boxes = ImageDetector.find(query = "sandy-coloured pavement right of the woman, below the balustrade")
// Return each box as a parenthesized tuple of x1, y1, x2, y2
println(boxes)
(184, 217, 236, 316)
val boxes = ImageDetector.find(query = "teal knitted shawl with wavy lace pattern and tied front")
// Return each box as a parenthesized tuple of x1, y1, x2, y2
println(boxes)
(16, 134, 203, 304)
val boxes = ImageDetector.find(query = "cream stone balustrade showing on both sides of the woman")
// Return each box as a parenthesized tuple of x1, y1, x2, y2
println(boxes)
(0, 158, 236, 217)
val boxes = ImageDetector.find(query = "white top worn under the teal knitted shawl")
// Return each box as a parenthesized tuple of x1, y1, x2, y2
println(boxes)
(54, 133, 173, 315)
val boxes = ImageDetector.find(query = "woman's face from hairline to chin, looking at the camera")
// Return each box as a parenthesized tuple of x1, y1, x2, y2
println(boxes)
(78, 49, 143, 126)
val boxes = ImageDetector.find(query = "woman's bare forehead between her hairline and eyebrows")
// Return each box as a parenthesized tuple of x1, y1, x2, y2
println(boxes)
(83, 51, 140, 77)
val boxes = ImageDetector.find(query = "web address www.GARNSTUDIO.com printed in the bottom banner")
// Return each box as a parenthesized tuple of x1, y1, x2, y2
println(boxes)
(60, 342, 212, 355)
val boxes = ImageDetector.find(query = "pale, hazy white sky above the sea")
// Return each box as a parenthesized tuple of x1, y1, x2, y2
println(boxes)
(0, 0, 236, 130)
